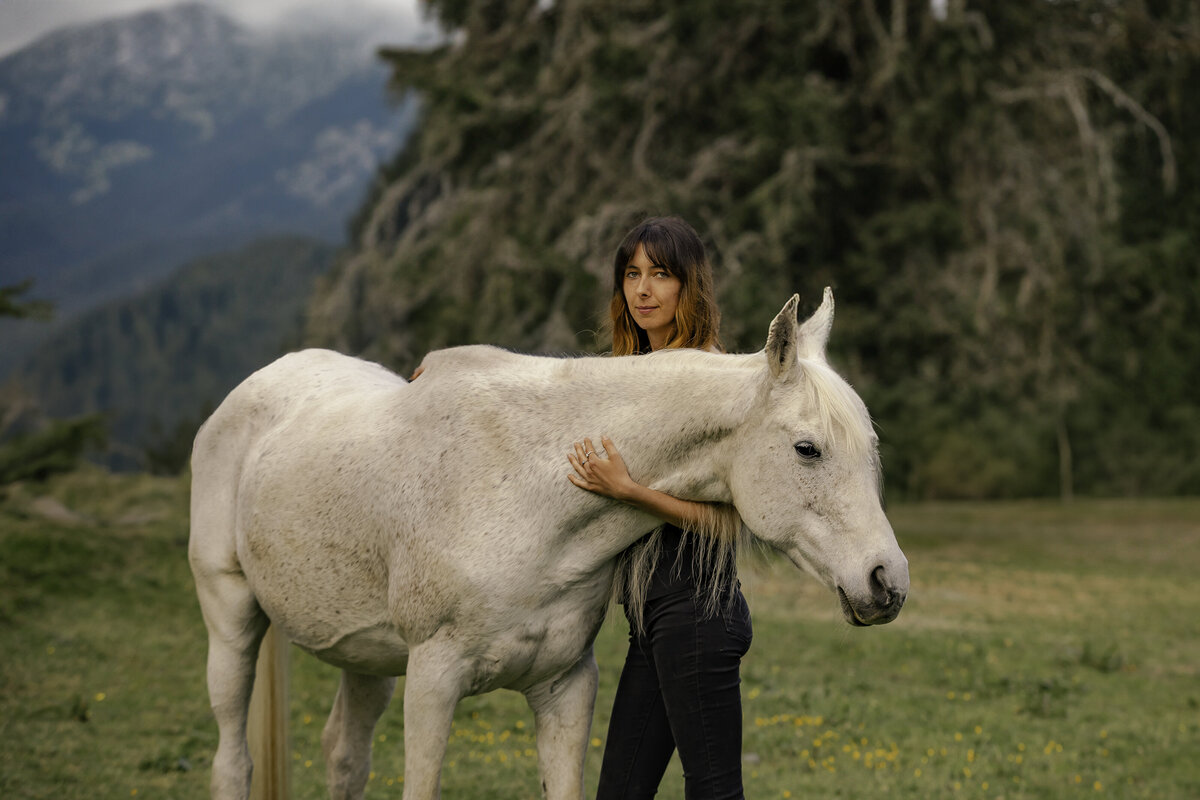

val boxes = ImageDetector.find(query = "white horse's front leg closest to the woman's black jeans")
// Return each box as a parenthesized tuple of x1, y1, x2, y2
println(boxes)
(526, 648, 599, 800)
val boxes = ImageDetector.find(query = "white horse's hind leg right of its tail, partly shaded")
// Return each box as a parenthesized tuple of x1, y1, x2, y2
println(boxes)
(320, 669, 396, 800)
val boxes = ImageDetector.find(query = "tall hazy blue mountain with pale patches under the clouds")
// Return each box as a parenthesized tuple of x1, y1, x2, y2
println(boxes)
(0, 4, 416, 373)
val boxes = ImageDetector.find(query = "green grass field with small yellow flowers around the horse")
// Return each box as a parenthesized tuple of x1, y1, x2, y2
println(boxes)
(0, 471, 1200, 800)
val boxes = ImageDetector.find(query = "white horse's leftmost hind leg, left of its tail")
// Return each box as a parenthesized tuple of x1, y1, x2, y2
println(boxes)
(196, 570, 268, 800)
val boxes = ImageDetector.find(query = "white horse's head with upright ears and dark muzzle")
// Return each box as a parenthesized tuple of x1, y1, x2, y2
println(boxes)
(730, 288, 908, 625)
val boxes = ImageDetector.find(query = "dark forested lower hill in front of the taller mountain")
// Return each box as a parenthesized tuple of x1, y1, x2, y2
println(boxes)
(12, 236, 336, 468)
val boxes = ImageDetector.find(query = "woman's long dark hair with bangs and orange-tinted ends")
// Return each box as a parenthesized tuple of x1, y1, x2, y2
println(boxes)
(608, 217, 721, 355)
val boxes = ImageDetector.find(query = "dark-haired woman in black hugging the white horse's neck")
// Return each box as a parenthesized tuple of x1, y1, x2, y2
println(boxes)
(568, 217, 751, 800)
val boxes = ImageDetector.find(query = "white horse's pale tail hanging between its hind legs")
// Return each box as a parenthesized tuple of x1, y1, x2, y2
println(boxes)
(246, 625, 290, 800)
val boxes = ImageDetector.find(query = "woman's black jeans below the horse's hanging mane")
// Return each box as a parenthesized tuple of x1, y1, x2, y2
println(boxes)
(596, 589, 752, 800)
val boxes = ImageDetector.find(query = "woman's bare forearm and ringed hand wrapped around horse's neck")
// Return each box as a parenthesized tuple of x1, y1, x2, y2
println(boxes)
(566, 437, 718, 530)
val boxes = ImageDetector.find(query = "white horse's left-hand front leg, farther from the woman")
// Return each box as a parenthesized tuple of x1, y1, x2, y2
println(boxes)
(404, 643, 468, 800)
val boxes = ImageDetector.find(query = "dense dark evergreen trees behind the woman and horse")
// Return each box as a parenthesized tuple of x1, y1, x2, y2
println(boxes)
(308, 0, 1200, 498)
